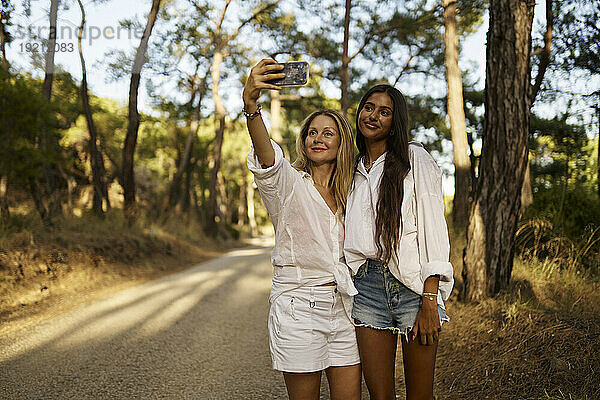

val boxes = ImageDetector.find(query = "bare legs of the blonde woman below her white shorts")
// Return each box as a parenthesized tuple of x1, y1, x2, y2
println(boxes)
(283, 364, 361, 400)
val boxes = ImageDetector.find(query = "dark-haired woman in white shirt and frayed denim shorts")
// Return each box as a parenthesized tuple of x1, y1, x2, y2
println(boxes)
(344, 85, 454, 400)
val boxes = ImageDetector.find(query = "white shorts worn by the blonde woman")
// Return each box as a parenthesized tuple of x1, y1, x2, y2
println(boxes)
(269, 286, 360, 372)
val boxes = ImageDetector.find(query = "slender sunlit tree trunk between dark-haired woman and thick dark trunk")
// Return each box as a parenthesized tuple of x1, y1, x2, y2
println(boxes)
(442, 0, 471, 230)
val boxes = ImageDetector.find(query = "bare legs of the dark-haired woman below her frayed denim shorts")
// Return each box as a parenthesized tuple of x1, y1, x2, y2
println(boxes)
(356, 327, 437, 400)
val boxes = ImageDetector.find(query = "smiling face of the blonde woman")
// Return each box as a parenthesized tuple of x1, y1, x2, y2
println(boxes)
(304, 115, 340, 165)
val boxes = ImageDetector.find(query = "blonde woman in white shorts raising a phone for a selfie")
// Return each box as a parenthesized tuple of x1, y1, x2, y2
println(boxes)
(243, 59, 361, 400)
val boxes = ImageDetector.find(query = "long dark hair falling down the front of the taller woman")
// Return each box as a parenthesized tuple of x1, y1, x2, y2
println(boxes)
(355, 85, 410, 262)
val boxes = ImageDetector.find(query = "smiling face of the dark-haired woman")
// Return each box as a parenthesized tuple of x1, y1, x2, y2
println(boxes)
(358, 92, 394, 142)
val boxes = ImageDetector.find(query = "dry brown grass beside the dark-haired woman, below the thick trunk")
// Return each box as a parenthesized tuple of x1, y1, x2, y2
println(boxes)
(435, 222, 600, 400)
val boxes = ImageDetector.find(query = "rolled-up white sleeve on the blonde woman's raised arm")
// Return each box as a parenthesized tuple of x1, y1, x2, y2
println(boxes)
(246, 139, 298, 222)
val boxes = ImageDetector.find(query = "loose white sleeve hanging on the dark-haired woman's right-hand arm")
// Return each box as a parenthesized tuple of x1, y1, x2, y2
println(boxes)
(412, 148, 454, 300)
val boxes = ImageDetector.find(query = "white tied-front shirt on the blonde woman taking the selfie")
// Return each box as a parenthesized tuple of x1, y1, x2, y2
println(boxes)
(247, 140, 358, 309)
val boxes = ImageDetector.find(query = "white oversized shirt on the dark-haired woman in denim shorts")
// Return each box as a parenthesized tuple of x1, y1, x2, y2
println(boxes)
(344, 142, 454, 307)
